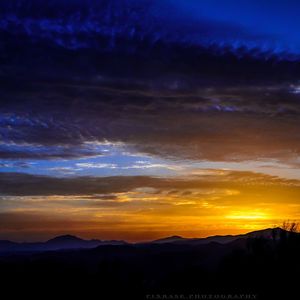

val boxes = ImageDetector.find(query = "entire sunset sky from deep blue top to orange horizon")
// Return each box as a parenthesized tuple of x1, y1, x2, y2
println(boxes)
(0, 0, 300, 242)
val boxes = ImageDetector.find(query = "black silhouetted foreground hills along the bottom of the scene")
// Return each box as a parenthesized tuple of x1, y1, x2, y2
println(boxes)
(0, 228, 300, 299)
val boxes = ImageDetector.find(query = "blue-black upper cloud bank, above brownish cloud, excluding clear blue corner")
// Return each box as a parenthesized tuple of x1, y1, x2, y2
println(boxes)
(0, 0, 300, 84)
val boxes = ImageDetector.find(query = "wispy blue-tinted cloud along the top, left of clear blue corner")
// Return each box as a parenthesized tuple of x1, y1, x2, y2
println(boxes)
(0, 0, 290, 52)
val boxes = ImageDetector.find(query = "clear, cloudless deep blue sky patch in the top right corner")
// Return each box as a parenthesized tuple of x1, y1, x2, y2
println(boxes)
(160, 0, 300, 53)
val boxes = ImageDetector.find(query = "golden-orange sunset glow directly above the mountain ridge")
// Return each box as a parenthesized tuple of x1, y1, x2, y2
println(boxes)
(2, 169, 300, 241)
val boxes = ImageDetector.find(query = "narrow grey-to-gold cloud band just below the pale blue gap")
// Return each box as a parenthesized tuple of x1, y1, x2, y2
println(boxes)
(0, 170, 299, 197)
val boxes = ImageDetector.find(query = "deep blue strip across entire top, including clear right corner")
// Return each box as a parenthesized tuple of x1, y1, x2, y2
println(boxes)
(0, 0, 300, 53)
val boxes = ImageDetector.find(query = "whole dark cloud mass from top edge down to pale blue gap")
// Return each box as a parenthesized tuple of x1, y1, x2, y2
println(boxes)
(0, 0, 300, 163)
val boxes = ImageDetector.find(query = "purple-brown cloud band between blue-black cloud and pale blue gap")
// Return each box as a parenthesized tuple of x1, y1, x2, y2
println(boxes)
(0, 82, 300, 164)
